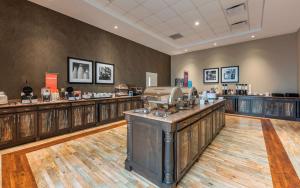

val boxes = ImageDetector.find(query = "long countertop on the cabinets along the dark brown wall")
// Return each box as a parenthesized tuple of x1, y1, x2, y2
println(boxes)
(0, 96, 141, 109)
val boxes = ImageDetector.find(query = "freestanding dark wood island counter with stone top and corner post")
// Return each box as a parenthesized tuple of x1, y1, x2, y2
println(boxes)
(125, 100, 225, 187)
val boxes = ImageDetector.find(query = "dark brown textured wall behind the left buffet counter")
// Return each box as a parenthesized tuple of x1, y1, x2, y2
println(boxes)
(0, 0, 171, 99)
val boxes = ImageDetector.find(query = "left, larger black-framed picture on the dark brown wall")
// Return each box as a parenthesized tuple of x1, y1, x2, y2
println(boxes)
(68, 57, 93, 84)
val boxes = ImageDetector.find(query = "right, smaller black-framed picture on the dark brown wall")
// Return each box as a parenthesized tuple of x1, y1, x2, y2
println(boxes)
(95, 62, 115, 84)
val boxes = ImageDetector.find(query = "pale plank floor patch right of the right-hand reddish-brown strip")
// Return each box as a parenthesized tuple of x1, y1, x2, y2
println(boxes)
(272, 120, 300, 177)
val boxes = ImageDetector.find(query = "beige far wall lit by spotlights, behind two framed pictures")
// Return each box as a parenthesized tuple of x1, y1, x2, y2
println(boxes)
(171, 33, 298, 93)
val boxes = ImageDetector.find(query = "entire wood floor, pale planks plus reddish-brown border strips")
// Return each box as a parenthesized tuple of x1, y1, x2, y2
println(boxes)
(2, 116, 300, 188)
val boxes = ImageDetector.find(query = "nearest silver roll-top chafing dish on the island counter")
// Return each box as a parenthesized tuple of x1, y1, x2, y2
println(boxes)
(136, 87, 183, 117)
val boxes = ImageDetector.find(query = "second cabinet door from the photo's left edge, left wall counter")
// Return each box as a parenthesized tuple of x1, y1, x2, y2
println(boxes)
(16, 111, 37, 143)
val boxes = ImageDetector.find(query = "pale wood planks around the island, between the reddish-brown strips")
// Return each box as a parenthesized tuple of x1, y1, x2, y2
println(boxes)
(26, 116, 272, 188)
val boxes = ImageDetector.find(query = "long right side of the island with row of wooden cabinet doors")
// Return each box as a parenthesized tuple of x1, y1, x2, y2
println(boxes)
(176, 106, 225, 179)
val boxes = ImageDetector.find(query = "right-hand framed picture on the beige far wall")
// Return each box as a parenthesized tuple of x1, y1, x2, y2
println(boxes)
(221, 66, 239, 83)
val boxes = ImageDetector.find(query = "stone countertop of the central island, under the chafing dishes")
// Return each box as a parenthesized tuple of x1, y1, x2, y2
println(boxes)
(124, 100, 225, 124)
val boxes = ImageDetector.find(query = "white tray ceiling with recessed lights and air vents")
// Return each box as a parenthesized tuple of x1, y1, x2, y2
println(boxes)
(30, 0, 300, 55)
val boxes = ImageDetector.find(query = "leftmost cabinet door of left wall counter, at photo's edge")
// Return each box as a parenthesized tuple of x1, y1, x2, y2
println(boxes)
(0, 114, 16, 148)
